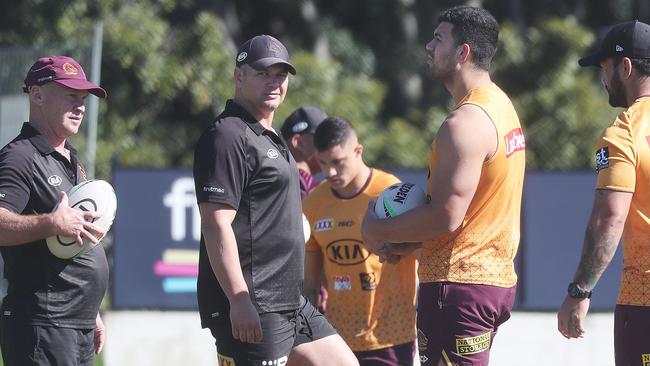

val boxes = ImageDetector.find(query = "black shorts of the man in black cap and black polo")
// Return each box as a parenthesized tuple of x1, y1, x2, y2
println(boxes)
(209, 297, 336, 366)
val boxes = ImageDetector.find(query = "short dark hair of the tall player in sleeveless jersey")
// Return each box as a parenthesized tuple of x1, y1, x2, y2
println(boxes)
(438, 6, 499, 70)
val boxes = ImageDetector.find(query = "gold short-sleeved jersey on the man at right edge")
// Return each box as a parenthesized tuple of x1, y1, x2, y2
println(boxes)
(596, 97, 650, 306)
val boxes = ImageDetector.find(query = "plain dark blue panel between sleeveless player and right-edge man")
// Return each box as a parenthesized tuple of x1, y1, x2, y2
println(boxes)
(518, 172, 623, 311)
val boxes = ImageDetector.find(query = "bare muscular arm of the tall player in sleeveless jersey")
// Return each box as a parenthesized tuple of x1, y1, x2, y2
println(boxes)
(362, 105, 497, 243)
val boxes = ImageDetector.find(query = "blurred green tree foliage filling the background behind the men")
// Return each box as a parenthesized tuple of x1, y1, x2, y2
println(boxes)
(0, 0, 650, 177)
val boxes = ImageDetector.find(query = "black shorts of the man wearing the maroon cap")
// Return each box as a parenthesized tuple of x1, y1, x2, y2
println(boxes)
(0, 317, 95, 366)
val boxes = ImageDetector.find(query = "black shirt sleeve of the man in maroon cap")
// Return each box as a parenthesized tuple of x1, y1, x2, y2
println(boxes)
(0, 148, 32, 214)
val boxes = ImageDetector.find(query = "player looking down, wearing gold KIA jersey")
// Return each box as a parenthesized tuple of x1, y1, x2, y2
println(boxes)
(303, 117, 417, 366)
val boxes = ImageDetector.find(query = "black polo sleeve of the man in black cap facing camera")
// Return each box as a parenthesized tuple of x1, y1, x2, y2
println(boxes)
(194, 120, 248, 209)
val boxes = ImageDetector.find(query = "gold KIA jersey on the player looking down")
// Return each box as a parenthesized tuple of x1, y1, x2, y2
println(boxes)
(303, 169, 417, 351)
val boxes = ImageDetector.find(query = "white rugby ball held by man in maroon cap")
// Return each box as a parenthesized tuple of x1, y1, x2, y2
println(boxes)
(46, 180, 117, 259)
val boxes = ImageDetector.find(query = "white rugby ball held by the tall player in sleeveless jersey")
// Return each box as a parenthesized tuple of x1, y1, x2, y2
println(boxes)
(375, 182, 427, 219)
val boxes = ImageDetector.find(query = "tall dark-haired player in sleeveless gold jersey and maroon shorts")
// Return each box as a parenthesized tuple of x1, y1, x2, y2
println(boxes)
(363, 6, 526, 365)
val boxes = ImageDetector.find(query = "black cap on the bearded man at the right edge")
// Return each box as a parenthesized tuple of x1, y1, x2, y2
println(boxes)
(578, 20, 650, 66)
